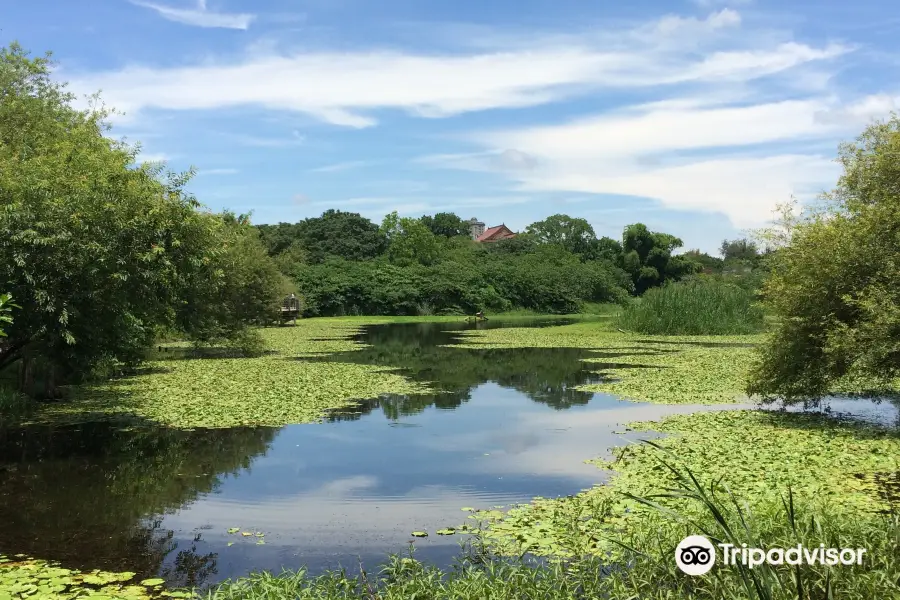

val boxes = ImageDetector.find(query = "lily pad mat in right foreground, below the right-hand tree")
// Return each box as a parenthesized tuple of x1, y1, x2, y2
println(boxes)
(473, 410, 900, 556)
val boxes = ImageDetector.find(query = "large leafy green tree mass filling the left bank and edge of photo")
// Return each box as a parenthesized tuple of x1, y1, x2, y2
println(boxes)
(0, 44, 282, 395)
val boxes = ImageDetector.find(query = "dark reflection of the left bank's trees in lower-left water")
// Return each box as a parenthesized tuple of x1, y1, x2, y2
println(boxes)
(0, 423, 277, 585)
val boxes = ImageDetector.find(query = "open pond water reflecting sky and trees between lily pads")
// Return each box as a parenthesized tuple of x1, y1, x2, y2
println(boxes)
(0, 319, 808, 585)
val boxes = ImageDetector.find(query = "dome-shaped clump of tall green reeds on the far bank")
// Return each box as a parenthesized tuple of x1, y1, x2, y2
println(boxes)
(619, 280, 765, 335)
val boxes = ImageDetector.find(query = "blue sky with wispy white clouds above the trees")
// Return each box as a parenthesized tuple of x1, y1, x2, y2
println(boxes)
(0, 0, 900, 251)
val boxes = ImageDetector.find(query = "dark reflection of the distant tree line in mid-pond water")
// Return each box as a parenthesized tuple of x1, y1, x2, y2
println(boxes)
(320, 323, 656, 420)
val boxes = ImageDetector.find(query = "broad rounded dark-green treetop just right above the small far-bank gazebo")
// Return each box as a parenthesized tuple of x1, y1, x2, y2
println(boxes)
(297, 209, 387, 263)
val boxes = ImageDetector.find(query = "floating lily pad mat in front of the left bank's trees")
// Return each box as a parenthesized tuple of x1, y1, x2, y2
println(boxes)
(30, 319, 430, 429)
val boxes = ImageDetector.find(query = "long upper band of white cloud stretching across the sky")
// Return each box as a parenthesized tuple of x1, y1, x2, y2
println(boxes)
(70, 9, 848, 128)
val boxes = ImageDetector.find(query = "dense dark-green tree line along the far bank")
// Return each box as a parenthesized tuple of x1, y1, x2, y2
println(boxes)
(257, 210, 759, 316)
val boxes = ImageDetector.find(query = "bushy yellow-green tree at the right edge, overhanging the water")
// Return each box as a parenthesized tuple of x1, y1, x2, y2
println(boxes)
(748, 114, 900, 402)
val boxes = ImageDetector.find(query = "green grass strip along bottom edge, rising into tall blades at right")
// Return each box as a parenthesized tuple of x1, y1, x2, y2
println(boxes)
(206, 443, 900, 600)
